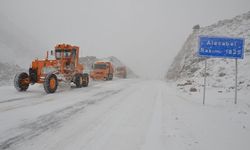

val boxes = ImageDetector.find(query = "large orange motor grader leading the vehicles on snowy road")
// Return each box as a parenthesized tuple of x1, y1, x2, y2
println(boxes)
(14, 44, 89, 93)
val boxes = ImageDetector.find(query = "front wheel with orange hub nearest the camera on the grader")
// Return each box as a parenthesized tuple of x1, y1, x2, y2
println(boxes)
(43, 74, 58, 94)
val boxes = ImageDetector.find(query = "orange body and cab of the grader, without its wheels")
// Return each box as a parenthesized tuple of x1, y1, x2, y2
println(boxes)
(29, 44, 84, 83)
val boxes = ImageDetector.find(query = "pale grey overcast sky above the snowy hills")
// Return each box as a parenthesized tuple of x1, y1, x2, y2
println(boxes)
(0, 0, 250, 78)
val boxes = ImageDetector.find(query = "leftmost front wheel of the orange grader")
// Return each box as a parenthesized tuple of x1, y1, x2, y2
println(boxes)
(14, 72, 29, 91)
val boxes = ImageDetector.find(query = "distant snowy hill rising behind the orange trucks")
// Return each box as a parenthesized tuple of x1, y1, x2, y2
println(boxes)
(79, 56, 138, 78)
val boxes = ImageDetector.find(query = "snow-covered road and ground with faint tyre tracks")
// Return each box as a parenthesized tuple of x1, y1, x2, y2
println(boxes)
(0, 79, 250, 150)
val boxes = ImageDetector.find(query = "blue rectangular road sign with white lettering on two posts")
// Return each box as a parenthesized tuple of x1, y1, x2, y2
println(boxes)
(199, 36, 245, 59)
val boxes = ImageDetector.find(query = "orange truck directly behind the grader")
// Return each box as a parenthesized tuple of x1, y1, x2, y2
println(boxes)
(90, 61, 114, 80)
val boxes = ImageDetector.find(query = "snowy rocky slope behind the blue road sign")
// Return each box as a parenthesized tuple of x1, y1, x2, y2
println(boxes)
(166, 11, 250, 92)
